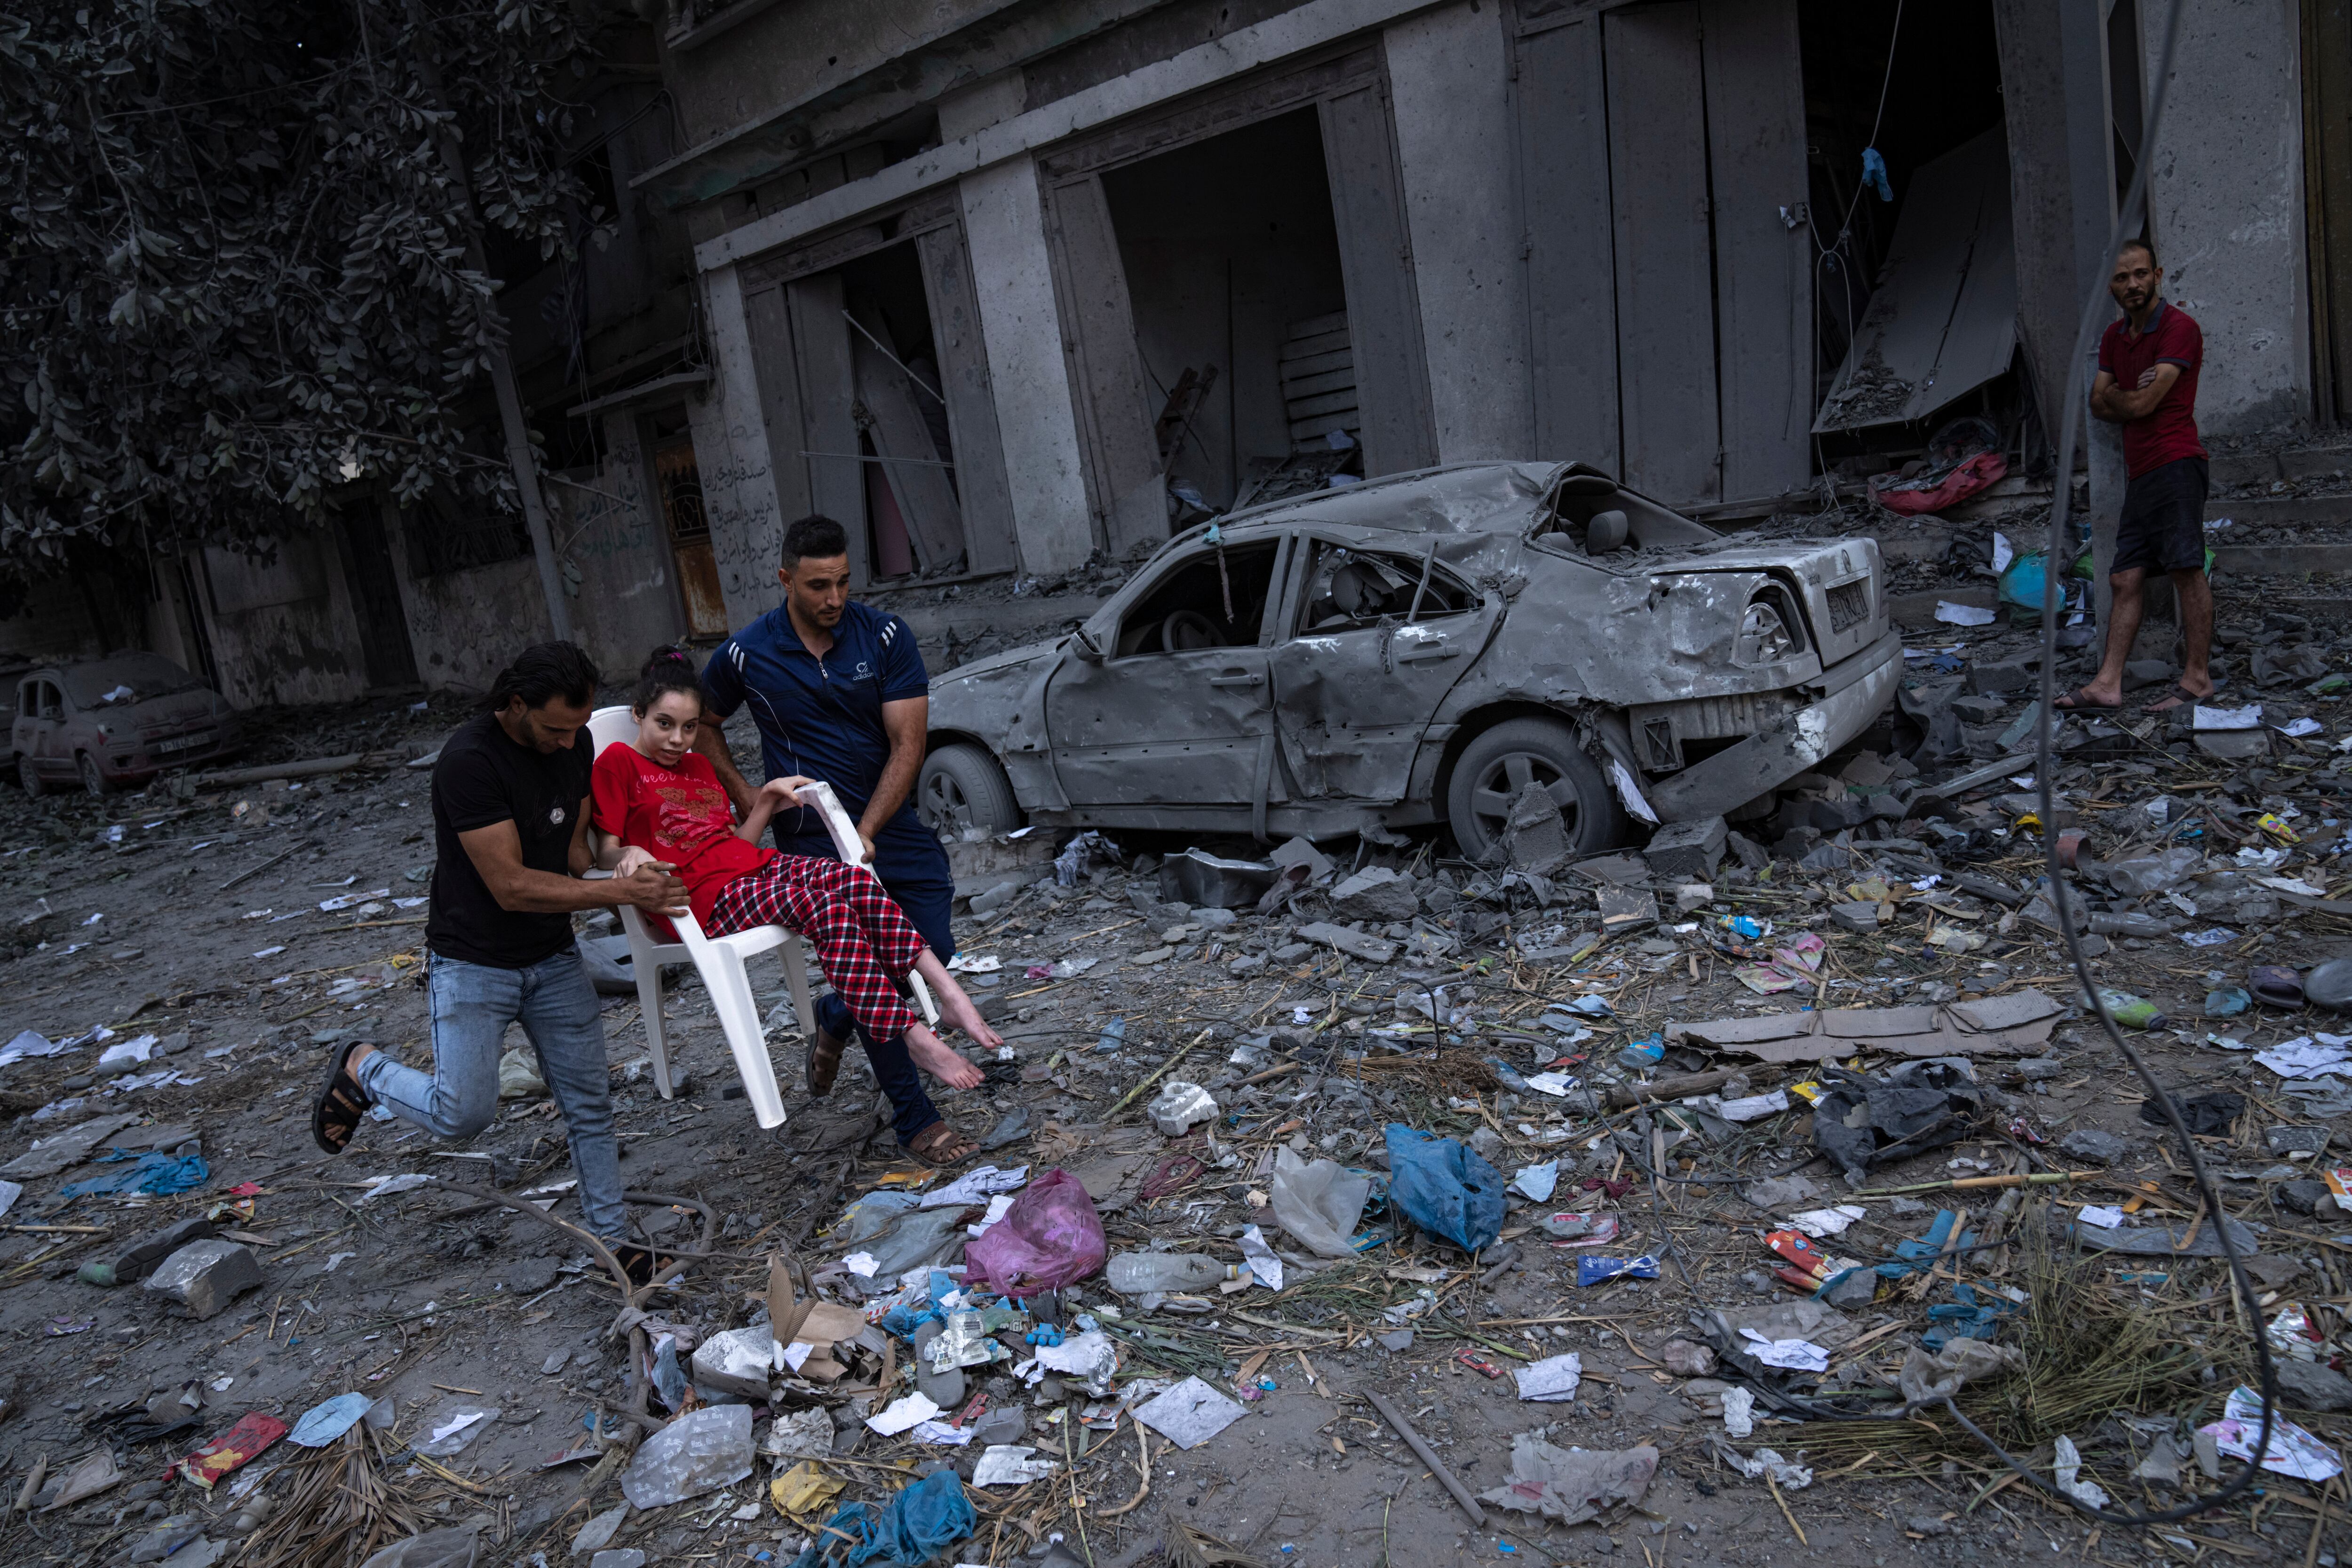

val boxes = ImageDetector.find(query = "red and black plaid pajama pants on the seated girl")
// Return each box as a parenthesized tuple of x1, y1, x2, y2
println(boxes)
(710, 855, 922, 1039)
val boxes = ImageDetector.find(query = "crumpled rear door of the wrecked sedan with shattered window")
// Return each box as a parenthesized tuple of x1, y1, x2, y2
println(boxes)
(1272, 534, 1503, 804)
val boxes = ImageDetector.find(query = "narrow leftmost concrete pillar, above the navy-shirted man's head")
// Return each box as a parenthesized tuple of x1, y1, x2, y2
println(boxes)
(687, 266, 786, 626)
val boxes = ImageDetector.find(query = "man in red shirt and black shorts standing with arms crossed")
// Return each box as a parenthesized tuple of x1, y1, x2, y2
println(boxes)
(2058, 240, 2213, 713)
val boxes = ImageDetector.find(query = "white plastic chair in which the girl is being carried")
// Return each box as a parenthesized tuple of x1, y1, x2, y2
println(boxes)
(588, 705, 938, 1128)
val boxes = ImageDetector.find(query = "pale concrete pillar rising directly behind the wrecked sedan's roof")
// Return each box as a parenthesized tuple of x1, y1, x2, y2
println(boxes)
(1385, 0, 1543, 463)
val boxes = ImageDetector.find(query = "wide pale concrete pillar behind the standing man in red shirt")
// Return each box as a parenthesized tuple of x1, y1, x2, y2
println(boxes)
(2143, 0, 2312, 435)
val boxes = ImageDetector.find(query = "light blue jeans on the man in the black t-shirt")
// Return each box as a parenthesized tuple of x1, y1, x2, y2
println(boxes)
(360, 947, 628, 1241)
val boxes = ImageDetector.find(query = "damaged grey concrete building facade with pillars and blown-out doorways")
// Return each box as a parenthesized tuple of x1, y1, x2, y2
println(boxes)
(0, 0, 2352, 703)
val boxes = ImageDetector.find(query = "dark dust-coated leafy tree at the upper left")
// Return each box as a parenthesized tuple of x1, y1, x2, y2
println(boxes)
(0, 0, 595, 630)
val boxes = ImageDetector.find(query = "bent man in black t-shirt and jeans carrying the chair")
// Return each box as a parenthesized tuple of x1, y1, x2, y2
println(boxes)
(310, 642, 687, 1279)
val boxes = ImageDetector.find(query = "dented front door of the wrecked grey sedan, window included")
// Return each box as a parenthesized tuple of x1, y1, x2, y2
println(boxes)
(1047, 534, 1289, 823)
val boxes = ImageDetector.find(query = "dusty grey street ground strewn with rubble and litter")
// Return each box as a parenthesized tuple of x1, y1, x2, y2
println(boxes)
(0, 545, 2352, 1568)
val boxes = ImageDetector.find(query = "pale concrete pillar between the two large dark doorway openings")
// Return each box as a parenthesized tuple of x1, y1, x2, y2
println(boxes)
(960, 153, 1094, 574)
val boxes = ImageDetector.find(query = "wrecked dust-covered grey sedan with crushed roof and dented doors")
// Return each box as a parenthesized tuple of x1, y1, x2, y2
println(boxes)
(917, 463, 1903, 858)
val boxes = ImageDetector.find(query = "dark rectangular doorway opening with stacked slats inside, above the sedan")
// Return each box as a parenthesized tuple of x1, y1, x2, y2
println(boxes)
(1101, 106, 1362, 527)
